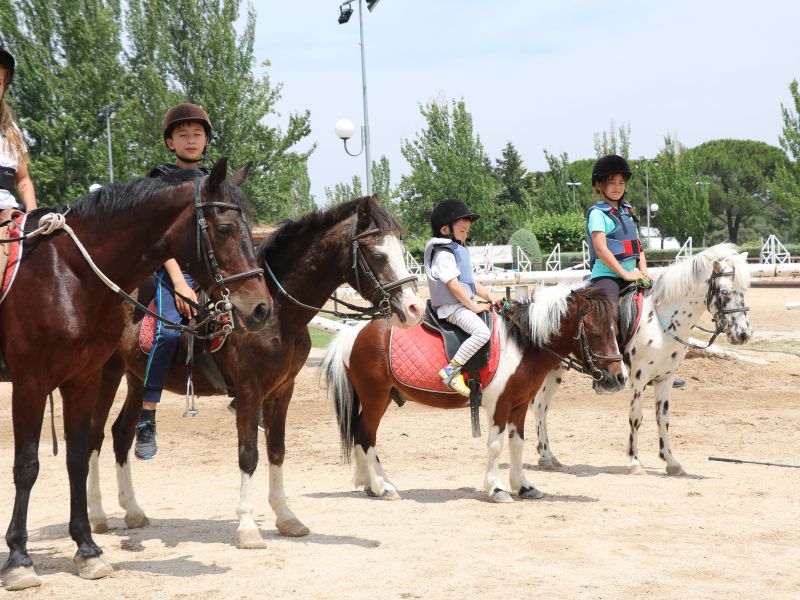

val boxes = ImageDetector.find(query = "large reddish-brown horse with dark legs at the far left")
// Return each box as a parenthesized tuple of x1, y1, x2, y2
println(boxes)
(0, 159, 272, 589)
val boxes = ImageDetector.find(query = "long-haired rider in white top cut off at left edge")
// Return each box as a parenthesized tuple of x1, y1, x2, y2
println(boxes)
(0, 46, 36, 222)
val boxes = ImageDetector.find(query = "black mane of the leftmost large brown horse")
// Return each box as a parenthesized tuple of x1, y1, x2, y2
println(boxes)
(60, 169, 253, 223)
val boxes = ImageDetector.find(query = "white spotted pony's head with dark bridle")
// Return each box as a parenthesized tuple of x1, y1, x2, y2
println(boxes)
(706, 252, 753, 344)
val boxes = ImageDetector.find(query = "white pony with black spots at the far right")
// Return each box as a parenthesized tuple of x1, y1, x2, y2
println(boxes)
(533, 244, 753, 475)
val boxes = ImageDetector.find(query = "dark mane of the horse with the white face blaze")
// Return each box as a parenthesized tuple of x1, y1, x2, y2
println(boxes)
(258, 198, 405, 262)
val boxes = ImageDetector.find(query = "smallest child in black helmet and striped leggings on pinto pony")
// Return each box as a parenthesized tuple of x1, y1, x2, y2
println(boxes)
(425, 199, 495, 398)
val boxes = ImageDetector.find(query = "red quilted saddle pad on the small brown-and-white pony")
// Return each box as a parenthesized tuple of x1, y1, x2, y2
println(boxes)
(389, 315, 500, 394)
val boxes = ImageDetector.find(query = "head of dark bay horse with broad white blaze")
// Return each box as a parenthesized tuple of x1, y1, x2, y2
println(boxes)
(348, 194, 424, 327)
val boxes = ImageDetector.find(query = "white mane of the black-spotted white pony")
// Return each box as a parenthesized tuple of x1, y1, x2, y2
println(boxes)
(653, 243, 750, 302)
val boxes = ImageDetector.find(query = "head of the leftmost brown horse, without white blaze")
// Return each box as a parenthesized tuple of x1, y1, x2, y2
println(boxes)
(190, 158, 272, 331)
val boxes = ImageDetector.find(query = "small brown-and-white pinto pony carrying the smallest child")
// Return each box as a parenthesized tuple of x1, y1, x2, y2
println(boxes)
(322, 285, 627, 502)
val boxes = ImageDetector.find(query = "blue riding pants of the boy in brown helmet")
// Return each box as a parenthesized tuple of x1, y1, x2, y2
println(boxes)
(142, 267, 194, 402)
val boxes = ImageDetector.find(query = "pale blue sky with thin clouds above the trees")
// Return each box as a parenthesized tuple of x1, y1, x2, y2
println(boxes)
(253, 0, 800, 203)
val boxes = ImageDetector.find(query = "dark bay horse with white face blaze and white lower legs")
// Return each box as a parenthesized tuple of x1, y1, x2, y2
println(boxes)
(89, 196, 423, 548)
